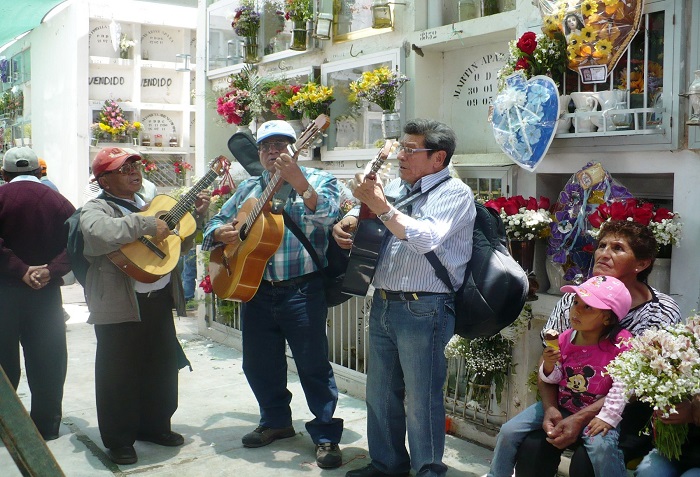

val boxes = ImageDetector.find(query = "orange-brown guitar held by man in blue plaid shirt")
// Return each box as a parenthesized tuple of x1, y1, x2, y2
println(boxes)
(209, 114, 330, 301)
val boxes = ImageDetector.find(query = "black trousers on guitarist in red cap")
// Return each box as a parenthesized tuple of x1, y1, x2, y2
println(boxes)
(95, 286, 178, 448)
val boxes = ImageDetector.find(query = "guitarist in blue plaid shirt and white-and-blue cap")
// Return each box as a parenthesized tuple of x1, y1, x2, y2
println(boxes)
(202, 120, 343, 469)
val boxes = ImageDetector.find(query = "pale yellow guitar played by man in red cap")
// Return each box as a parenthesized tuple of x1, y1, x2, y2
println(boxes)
(107, 156, 228, 283)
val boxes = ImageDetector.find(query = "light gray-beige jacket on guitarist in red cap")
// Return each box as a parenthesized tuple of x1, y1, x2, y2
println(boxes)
(80, 199, 186, 325)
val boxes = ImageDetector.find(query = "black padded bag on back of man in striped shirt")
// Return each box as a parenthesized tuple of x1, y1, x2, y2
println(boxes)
(425, 203, 529, 339)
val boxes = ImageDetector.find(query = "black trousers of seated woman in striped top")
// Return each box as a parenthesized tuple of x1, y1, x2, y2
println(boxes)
(515, 401, 653, 477)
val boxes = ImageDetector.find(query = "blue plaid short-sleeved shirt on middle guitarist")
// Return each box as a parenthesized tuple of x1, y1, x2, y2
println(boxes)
(202, 166, 339, 281)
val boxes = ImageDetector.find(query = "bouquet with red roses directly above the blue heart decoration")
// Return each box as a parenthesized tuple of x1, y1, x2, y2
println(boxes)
(498, 31, 567, 91)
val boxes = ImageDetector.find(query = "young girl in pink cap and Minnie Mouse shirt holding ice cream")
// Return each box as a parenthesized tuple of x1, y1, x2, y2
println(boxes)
(487, 276, 632, 477)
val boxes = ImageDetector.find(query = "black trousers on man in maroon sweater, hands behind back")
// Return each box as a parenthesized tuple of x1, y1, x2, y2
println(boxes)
(0, 286, 68, 439)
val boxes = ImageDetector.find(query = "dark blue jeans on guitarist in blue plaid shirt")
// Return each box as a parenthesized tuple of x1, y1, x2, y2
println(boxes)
(241, 276, 343, 444)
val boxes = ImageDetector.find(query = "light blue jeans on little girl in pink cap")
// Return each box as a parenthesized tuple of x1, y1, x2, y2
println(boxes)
(487, 402, 627, 477)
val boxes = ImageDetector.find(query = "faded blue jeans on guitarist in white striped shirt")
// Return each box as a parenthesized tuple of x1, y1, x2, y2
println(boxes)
(367, 292, 454, 477)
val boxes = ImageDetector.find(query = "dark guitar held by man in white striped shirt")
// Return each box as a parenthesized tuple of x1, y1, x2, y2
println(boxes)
(342, 139, 396, 296)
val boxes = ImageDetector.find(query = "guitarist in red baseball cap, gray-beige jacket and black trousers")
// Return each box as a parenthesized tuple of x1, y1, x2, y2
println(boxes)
(80, 147, 209, 464)
